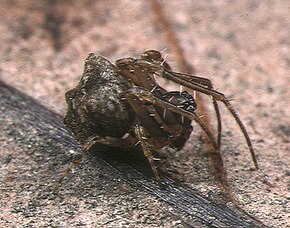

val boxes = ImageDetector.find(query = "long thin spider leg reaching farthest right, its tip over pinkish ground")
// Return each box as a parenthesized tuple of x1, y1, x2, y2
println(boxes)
(163, 70, 259, 169)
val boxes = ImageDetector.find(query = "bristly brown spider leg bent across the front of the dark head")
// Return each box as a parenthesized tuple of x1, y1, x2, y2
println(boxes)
(125, 87, 219, 150)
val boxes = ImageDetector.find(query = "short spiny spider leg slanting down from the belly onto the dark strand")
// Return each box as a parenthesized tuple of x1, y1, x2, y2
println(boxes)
(134, 123, 162, 187)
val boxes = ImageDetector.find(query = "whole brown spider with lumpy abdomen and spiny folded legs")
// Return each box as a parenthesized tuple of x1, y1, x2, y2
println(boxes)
(64, 50, 258, 184)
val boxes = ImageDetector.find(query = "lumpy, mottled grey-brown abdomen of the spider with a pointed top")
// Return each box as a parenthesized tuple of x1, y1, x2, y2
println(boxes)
(64, 53, 134, 144)
